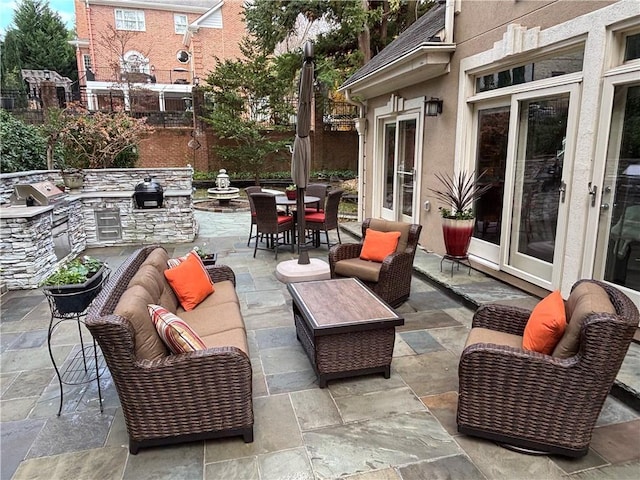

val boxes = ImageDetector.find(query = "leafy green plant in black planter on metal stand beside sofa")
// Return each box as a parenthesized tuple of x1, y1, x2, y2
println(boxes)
(41, 255, 108, 314)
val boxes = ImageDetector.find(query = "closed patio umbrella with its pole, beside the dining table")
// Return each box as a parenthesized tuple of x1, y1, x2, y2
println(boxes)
(291, 41, 314, 265)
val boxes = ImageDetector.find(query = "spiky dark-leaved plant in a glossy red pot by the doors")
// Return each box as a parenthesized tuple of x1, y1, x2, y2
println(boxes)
(429, 170, 491, 258)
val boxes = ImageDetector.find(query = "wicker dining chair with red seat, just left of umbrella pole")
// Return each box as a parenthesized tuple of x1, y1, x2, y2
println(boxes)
(250, 193, 295, 260)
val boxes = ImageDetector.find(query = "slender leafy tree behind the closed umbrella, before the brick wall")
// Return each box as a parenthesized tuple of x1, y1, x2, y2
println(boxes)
(203, 38, 294, 182)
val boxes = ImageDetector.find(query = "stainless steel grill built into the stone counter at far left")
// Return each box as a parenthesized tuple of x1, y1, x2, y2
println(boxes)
(9, 181, 71, 260)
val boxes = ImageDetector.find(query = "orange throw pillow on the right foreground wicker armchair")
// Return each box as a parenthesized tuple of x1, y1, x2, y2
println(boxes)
(522, 290, 567, 355)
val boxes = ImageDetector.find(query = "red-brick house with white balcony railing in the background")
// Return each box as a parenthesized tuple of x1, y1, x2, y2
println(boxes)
(71, 0, 246, 111)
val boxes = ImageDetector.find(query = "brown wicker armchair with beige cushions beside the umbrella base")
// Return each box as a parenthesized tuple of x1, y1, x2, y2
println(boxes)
(329, 218, 422, 307)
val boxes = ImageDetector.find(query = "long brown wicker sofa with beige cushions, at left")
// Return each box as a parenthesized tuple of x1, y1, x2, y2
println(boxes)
(87, 246, 253, 454)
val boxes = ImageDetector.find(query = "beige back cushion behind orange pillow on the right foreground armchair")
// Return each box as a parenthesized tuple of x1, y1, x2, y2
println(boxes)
(552, 282, 616, 358)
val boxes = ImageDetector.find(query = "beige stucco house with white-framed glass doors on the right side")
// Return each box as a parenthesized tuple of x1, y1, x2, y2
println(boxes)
(340, 0, 640, 305)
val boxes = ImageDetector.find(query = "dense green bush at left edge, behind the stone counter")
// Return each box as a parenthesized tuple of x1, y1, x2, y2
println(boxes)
(0, 110, 47, 173)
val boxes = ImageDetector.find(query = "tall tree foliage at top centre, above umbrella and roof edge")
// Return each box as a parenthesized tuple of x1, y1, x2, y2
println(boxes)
(245, 0, 435, 87)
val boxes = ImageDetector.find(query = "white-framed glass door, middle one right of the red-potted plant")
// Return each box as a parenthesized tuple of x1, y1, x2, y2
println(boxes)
(504, 92, 574, 288)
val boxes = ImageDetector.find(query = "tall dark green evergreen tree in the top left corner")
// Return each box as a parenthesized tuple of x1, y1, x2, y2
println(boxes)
(1, 0, 77, 88)
